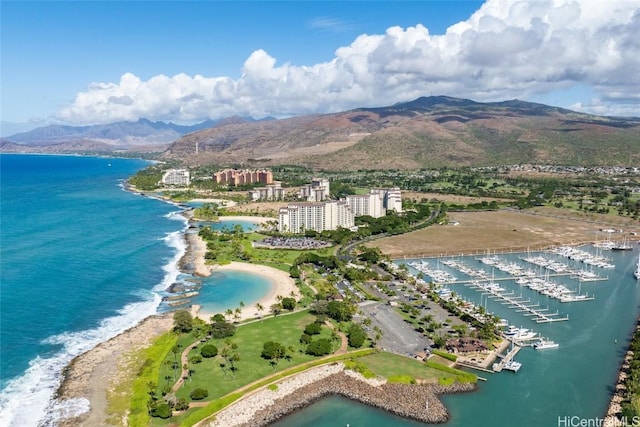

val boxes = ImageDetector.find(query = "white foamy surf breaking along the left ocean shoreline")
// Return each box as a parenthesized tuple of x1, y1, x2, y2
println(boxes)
(0, 215, 187, 427)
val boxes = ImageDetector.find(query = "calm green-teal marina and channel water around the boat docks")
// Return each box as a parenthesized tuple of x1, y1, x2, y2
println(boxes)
(276, 248, 640, 427)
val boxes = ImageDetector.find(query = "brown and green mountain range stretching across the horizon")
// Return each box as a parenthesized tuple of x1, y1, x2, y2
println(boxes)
(0, 96, 640, 170)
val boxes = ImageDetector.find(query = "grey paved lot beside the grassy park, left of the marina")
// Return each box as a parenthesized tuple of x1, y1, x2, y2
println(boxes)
(360, 302, 433, 356)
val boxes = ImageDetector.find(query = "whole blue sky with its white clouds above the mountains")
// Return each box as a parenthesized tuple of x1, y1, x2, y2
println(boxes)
(0, 0, 640, 136)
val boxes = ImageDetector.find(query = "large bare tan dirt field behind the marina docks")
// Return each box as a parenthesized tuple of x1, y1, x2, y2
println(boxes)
(367, 208, 640, 258)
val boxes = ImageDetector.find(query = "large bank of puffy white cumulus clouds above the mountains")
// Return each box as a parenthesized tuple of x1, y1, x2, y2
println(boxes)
(58, 0, 640, 124)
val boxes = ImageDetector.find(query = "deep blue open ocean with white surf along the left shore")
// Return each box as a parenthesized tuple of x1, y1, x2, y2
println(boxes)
(0, 154, 270, 427)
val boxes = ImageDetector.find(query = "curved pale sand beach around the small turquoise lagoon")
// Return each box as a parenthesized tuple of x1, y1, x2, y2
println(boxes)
(198, 262, 300, 321)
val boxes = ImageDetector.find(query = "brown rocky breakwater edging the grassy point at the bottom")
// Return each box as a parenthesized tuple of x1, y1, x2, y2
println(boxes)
(209, 365, 475, 427)
